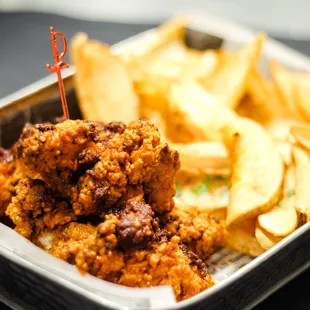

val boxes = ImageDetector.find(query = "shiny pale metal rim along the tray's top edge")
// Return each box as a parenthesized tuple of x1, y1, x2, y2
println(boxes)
(0, 14, 310, 310)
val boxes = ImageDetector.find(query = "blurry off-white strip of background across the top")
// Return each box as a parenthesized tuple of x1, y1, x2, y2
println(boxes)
(4, 0, 310, 39)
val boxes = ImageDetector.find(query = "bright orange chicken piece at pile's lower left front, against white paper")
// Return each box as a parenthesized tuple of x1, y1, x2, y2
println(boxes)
(44, 214, 125, 282)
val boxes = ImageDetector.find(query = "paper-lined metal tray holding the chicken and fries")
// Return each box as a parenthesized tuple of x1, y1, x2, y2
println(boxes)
(0, 14, 310, 310)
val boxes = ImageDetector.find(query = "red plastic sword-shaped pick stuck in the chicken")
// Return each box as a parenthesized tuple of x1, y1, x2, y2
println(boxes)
(46, 27, 69, 119)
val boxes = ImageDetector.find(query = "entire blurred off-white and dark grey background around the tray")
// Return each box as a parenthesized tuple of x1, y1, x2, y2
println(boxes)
(0, 0, 310, 310)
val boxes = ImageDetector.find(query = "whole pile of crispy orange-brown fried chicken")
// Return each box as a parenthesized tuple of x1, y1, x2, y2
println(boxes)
(0, 120, 222, 300)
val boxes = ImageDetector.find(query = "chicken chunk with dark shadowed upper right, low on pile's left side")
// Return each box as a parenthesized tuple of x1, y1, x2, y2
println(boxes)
(6, 178, 75, 238)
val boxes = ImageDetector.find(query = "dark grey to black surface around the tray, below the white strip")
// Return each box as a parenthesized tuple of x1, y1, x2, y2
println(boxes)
(0, 13, 310, 310)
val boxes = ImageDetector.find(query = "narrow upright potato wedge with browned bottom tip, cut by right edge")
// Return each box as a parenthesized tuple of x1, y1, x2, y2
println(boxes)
(293, 146, 310, 221)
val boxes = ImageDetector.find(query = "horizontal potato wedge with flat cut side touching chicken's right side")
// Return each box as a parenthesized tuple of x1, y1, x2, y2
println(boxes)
(170, 142, 231, 175)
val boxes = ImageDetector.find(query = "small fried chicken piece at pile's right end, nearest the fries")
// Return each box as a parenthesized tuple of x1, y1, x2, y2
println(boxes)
(161, 207, 224, 259)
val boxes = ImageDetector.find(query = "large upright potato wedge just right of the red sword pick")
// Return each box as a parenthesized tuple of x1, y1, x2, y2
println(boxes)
(71, 33, 139, 123)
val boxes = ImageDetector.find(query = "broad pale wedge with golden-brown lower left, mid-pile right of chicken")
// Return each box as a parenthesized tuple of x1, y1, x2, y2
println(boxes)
(168, 79, 237, 143)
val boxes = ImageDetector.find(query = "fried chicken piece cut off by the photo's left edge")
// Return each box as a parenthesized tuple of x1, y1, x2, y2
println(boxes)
(0, 148, 23, 217)
